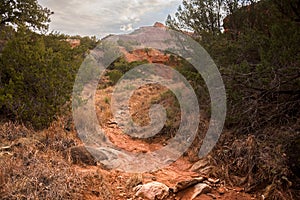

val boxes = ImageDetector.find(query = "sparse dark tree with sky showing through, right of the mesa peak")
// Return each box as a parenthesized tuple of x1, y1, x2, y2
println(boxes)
(166, 0, 257, 35)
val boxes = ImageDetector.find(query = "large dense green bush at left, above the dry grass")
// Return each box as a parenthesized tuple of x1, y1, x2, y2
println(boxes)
(0, 29, 90, 128)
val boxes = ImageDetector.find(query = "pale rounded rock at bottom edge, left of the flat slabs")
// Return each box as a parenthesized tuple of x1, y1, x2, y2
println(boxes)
(135, 181, 169, 200)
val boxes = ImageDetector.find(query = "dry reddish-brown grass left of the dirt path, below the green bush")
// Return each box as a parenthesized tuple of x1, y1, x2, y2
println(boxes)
(0, 120, 112, 199)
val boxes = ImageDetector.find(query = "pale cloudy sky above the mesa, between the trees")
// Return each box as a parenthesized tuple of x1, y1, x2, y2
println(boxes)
(38, 0, 182, 38)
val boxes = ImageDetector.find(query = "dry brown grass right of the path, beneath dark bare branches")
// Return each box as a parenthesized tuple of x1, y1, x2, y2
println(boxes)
(213, 128, 300, 200)
